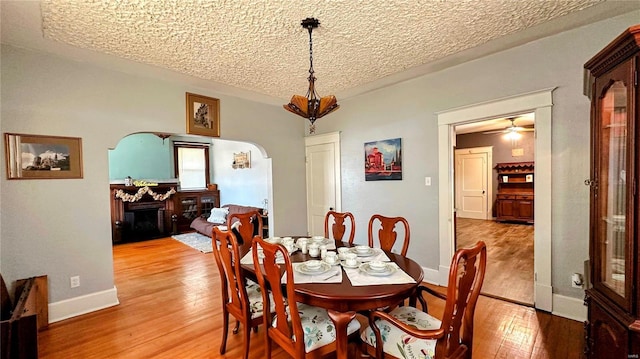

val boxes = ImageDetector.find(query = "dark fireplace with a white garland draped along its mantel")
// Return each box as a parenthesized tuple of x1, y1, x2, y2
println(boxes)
(110, 183, 177, 244)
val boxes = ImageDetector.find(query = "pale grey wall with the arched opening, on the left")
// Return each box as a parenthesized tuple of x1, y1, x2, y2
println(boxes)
(0, 45, 306, 315)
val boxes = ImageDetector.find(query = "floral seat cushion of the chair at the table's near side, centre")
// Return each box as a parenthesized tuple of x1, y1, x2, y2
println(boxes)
(273, 303, 360, 353)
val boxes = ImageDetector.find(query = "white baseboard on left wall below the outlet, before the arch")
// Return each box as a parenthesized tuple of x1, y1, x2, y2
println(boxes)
(49, 286, 120, 323)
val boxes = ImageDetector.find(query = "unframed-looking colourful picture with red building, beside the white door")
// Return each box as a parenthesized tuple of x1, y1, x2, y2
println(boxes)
(364, 138, 402, 181)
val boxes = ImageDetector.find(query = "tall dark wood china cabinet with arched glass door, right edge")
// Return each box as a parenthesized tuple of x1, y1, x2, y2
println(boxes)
(584, 25, 640, 358)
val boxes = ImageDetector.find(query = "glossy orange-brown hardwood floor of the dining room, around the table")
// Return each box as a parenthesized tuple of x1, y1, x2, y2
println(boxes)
(38, 238, 584, 359)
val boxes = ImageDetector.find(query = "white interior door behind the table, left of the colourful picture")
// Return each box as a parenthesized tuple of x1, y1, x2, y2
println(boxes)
(305, 133, 342, 236)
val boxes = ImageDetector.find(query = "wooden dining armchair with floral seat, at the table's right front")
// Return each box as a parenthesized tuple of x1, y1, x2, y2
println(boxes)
(361, 241, 487, 359)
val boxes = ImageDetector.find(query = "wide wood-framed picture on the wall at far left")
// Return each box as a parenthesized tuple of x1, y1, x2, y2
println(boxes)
(4, 133, 82, 179)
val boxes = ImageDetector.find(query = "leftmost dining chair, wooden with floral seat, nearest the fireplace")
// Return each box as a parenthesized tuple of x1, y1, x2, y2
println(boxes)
(212, 227, 269, 359)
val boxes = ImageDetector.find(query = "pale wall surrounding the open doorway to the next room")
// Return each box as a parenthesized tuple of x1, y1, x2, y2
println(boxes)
(317, 11, 640, 298)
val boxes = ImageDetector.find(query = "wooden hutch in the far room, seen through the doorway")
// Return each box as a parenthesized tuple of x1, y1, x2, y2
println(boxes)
(495, 162, 534, 223)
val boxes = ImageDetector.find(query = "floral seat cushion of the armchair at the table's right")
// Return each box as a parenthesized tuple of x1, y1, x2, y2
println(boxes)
(360, 307, 440, 359)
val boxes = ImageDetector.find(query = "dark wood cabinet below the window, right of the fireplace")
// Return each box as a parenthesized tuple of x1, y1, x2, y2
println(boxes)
(174, 190, 220, 233)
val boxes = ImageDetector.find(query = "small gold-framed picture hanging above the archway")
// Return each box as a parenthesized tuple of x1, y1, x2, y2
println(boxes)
(187, 92, 220, 137)
